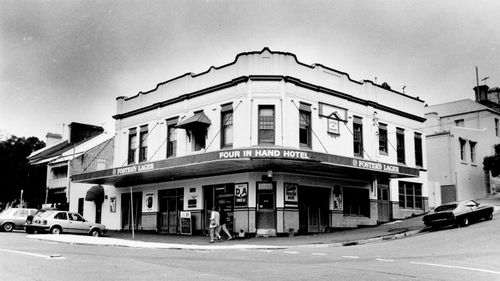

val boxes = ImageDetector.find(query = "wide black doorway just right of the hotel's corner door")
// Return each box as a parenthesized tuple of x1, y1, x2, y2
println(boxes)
(298, 186, 331, 233)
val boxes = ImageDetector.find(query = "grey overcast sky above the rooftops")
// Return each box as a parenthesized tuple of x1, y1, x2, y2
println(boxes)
(0, 0, 500, 140)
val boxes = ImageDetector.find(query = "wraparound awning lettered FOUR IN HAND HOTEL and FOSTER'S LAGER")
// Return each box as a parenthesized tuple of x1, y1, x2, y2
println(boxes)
(72, 148, 420, 187)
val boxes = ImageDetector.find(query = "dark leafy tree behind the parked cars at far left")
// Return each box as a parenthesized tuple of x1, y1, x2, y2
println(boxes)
(0, 136, 46, 206)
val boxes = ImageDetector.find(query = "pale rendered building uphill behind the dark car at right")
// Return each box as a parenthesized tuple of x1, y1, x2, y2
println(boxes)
(425, 85, 500, 206)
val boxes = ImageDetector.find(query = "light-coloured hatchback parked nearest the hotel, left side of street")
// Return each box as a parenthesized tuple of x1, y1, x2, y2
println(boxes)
(25, 210, 106, 236)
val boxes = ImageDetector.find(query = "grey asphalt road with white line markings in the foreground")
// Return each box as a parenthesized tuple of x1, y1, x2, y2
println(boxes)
(0, 216, 500, 281)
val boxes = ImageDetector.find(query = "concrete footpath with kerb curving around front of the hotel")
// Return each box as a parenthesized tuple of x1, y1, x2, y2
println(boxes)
(27, 194, 500, 250)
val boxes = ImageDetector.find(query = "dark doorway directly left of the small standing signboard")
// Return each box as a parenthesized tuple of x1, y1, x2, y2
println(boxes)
(158, 188, 184, 234)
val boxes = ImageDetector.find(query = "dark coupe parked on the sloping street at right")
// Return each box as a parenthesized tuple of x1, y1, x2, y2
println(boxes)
(423, 200, 493, 228)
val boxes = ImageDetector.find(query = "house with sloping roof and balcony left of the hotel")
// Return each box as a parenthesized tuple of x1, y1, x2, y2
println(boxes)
(28, 122, 104, 210)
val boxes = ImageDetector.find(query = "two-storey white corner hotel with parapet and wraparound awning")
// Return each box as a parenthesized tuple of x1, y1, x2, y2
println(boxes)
(72, 48, 428, 236)
